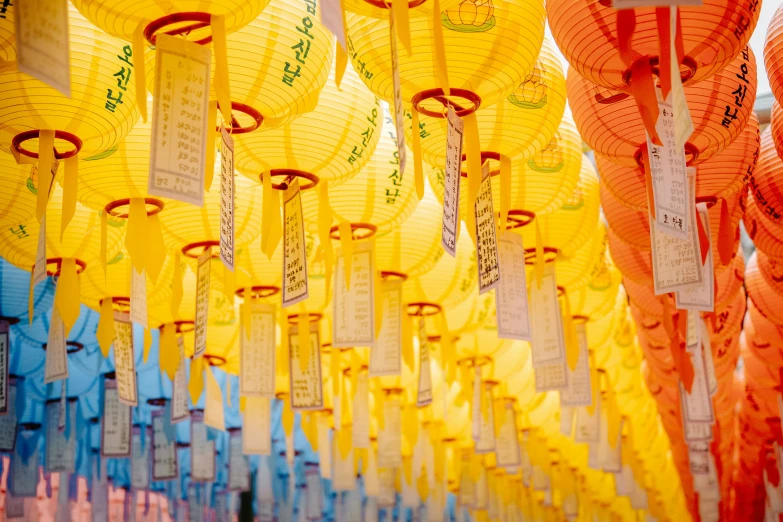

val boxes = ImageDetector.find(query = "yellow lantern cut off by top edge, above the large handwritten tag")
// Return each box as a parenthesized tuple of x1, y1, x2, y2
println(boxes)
(68, 0, 268, 42)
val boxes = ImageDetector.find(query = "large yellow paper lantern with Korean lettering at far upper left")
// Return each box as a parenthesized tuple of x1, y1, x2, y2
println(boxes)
(0, 4, 138, 159)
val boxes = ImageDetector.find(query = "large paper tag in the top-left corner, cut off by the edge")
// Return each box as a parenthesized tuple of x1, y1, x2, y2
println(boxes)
(15, 0, 71, 98)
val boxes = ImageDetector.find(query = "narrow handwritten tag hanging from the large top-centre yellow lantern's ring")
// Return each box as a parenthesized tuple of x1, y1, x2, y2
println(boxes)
(440, 105, 465, 257)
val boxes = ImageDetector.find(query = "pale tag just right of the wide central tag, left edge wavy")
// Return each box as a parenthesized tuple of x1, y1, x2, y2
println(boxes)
(369, 280, 402, 377)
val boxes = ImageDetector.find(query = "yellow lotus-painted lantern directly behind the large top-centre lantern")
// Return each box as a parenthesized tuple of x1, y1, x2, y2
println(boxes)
(414, 39, 566, 167)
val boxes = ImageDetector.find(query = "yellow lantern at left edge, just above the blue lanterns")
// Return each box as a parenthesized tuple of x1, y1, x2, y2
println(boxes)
(0, 183, 124, 273)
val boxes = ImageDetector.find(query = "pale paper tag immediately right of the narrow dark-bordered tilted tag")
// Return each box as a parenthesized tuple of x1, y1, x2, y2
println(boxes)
(495, 231, 531, 341)
